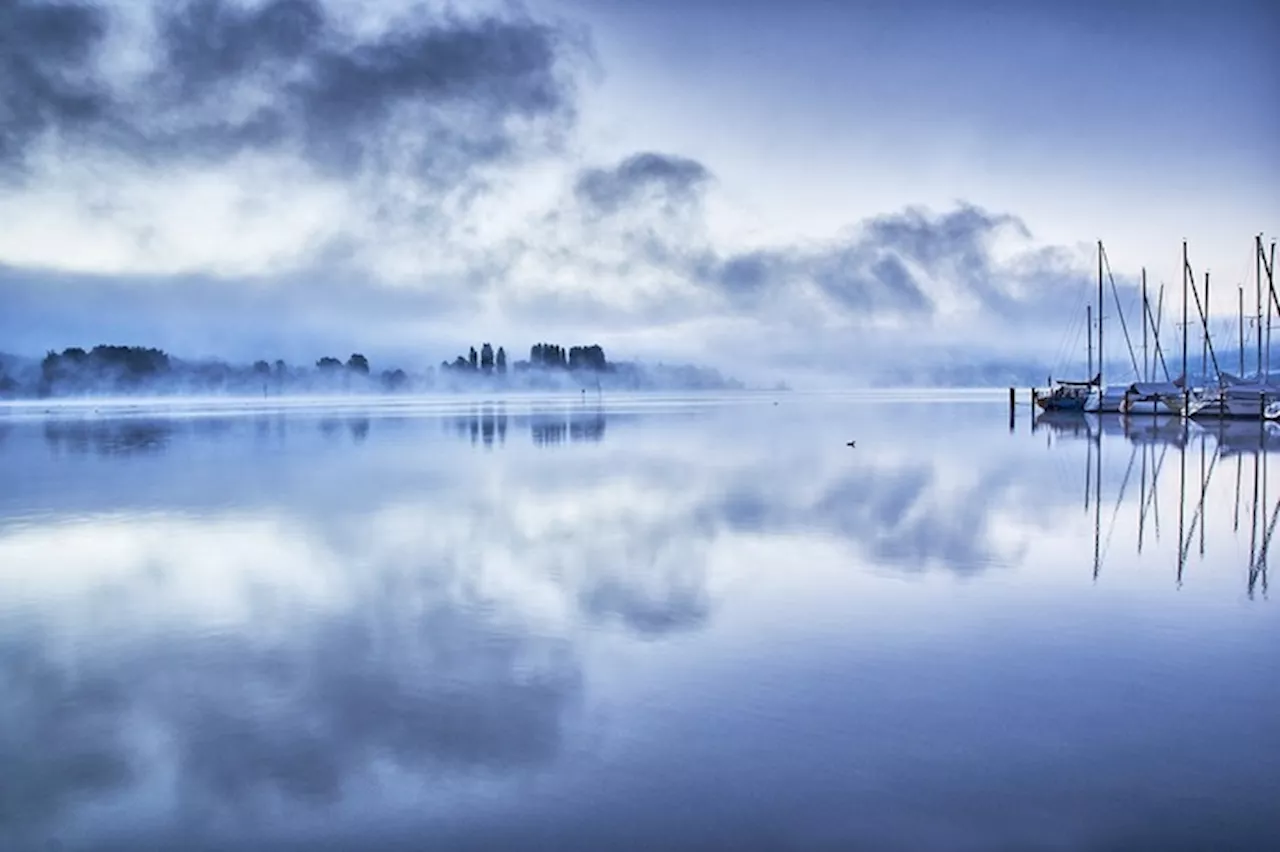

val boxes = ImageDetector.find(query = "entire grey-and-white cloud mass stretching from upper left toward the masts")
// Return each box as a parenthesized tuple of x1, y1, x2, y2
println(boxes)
(0, 0, 1131, 383)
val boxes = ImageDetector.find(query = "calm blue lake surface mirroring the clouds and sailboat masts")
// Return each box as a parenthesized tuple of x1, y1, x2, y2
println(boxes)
(0, 393, 1280, 852)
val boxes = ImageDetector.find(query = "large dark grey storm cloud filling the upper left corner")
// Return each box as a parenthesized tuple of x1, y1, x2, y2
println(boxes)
(0, 0, 572, 179)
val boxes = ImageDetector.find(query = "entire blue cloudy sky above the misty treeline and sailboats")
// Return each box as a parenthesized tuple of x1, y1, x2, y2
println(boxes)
(0, 0, 1280, 381)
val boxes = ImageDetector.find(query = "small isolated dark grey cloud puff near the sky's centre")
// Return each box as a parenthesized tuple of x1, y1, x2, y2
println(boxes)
(573, 151, 712, 215)
